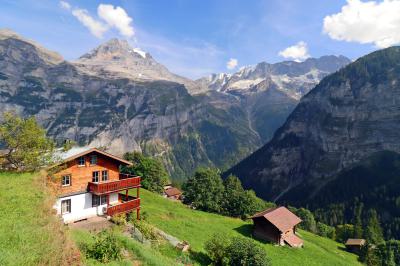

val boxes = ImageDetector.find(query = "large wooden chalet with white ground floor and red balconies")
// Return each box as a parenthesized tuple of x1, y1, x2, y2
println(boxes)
(51, 148, 140, 223)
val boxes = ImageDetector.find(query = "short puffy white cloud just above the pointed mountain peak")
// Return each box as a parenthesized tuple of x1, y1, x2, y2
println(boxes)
(97, 4, 134, 38)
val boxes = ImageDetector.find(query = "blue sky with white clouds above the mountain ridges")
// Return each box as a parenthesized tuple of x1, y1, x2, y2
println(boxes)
(0, 0, 394, 78)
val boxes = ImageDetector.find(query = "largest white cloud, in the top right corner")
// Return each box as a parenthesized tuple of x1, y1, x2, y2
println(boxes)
(323, 0, 400, 48)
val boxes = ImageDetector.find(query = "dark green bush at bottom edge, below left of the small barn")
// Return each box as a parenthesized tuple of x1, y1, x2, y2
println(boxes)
(205, 234, 270, 266)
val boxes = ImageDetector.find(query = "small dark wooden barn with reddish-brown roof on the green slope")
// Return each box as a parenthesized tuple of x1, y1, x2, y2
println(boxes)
(251, 207, 303, 247)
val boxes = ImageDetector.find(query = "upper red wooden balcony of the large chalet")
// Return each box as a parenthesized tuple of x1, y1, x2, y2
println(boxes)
(89, 174, 140, 195)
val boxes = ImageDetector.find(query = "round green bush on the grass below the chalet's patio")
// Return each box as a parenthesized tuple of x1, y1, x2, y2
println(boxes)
(83, 230, 122, 263)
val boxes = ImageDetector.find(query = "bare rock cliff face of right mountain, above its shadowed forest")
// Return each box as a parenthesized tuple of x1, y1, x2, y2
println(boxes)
(228, 47, 400, 204)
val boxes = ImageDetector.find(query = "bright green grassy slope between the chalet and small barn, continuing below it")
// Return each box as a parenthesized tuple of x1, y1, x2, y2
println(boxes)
(141, 189, 360, 266)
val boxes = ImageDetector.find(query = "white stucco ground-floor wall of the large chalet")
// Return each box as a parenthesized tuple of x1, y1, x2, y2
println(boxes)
(54, 193, 118, 223)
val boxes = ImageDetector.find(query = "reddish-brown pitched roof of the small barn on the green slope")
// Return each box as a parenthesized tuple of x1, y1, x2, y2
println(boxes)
(251, 206, 301, 232)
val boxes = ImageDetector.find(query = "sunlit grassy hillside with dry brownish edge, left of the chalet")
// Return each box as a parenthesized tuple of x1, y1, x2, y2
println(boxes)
(0, 173, 79, 266)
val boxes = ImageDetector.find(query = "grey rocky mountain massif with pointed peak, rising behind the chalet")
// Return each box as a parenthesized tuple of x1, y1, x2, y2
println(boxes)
(0, 30, 344, 178)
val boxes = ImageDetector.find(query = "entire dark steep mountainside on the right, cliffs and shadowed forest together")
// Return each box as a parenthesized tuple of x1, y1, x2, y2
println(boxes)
(227, 47, 400, 238)
